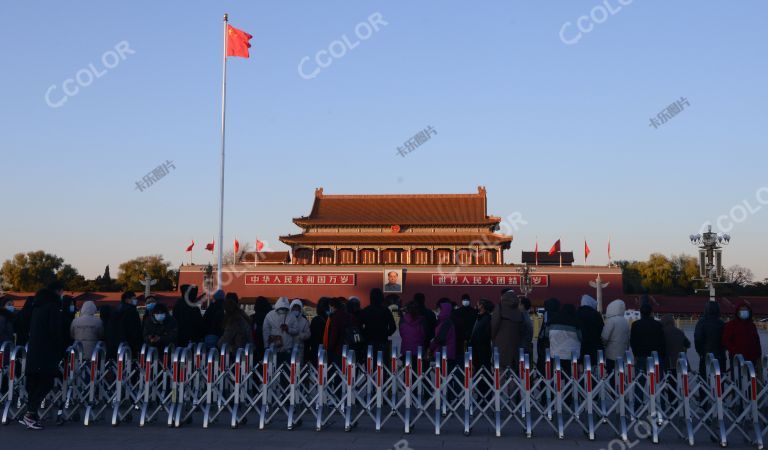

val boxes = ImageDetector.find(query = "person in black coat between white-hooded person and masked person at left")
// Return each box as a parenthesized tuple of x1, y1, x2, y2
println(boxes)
(104, 291, 144, 359)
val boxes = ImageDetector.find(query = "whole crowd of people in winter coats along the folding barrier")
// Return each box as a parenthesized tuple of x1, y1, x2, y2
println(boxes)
(0, 282, 762, 429)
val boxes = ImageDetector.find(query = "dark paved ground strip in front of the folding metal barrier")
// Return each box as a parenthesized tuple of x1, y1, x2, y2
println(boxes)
(0, 421, 754, 450)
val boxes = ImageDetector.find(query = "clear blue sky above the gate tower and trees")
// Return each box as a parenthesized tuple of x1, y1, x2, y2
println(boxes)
(0, 0, 768, 278)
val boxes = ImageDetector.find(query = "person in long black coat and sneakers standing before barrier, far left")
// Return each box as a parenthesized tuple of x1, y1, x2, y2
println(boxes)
(20, 282, 66, 430)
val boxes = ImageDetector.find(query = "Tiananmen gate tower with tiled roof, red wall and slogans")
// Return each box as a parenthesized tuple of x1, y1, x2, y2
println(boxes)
(179, 186, 622, 304)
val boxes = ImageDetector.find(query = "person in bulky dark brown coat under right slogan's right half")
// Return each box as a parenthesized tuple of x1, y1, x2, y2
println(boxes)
(491, 290, 525, 368)
